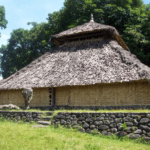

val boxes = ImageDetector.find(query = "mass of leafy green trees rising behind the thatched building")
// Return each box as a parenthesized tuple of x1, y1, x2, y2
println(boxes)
(0, 0, 150, 78)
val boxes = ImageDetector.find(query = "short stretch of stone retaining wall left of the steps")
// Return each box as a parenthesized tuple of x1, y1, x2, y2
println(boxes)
(0, 111, 43, 122)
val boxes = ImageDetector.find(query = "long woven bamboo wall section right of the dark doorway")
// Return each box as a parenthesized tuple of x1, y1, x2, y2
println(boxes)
(56, 83, 150, 106)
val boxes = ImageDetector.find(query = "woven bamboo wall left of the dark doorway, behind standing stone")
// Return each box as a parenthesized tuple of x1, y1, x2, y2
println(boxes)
(0, 88, 49, 106)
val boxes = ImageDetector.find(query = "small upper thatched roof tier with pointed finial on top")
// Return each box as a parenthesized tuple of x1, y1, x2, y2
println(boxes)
(51, 15, 129, 50)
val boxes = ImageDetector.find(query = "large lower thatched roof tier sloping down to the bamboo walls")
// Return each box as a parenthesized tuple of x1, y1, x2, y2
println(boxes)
(0, 39, 150, 89)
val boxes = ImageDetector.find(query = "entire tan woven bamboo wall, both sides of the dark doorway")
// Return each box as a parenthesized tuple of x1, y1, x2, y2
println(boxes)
(0, 83, 150, 106)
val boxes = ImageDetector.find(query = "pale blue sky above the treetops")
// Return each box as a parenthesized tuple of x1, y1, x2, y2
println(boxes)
(0, 0, 150, 79)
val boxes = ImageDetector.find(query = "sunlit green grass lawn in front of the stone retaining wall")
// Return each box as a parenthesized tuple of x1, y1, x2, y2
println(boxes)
(0, 121, 150, 150)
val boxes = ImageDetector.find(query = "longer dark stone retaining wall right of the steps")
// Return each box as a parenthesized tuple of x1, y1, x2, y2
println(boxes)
(52, 113, 150, 141)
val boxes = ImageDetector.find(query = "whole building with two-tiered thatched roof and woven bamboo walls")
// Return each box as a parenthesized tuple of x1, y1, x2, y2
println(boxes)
(0, 17, 150, 108)
